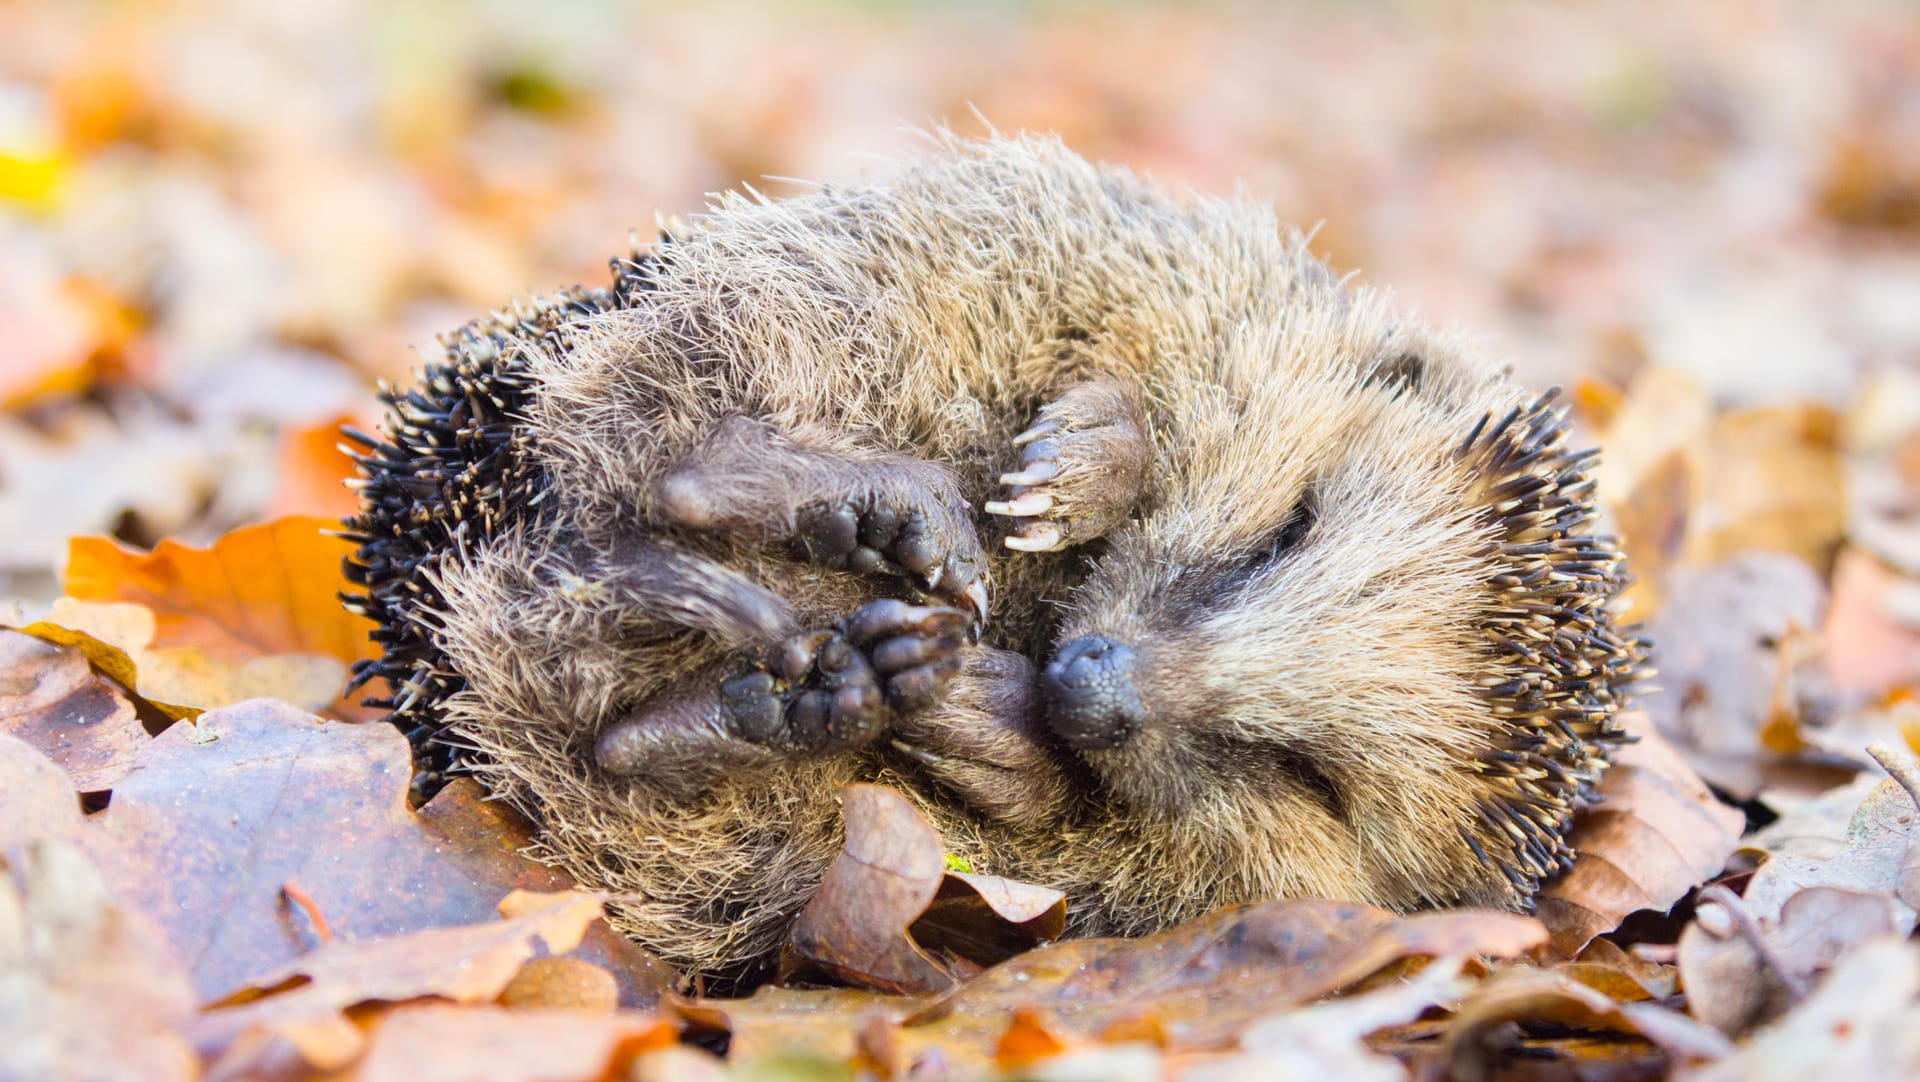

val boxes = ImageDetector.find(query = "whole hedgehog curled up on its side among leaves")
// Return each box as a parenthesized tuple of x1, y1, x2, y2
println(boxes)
(337, 138, 1645, 978)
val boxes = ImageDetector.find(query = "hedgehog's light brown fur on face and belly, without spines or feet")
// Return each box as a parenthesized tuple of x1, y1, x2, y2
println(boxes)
(389, 138, 1635, 973)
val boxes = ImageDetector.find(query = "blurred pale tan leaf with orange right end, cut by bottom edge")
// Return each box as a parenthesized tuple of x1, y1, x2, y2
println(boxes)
(348, 1003, 678, 1082)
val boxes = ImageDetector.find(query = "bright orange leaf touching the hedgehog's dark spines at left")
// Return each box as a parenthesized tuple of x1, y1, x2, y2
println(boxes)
(65, 516, 378, 664)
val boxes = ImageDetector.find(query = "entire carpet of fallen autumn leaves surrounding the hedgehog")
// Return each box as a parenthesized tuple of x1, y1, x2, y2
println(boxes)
(0, 0, 1920, 1082)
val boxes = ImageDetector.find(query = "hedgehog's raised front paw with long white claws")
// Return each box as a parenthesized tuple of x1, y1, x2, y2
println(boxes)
(985, 380, 1154, 553)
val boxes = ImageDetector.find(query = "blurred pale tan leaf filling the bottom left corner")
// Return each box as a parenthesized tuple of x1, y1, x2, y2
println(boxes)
(0, 836, 198, 1080)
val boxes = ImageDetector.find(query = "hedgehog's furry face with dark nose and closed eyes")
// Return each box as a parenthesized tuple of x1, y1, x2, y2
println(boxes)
(1043, 366, 1490, 836)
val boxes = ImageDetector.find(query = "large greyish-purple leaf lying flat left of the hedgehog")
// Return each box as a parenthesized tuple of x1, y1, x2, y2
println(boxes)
(76, 700, 637, 998)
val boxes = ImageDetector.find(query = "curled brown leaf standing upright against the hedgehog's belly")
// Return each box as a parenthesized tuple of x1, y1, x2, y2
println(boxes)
(787, 785, 1066, 994)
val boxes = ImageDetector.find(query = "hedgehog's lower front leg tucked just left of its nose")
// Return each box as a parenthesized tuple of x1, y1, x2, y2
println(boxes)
(891, 647, 1073, 827)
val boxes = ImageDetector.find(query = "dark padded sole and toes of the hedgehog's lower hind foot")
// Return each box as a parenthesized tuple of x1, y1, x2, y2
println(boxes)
(720, 600, 970, 752)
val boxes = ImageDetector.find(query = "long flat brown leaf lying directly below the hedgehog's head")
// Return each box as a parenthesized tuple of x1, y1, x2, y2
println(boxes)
(914, 900, 1546, 1047)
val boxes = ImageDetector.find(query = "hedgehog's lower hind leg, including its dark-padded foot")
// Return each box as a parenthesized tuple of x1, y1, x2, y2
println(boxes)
(595, 599, 968, 792)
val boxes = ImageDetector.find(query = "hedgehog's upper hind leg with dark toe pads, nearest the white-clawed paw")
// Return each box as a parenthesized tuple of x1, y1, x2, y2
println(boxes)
(655, 416, 987, 622)
